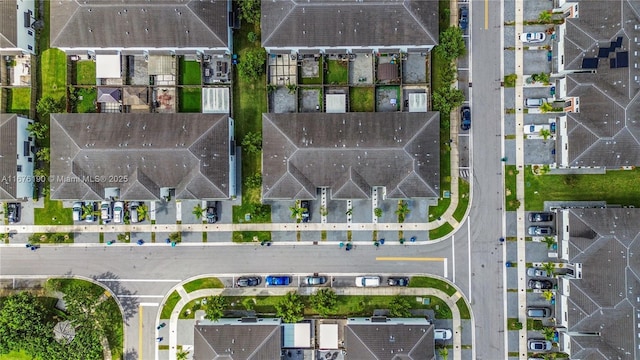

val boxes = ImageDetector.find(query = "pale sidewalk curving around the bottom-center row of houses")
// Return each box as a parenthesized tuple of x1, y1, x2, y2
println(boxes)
(160, 285, 468, 360)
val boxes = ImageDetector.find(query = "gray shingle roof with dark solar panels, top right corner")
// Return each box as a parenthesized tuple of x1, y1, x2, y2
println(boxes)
(558, 0, 640, 168)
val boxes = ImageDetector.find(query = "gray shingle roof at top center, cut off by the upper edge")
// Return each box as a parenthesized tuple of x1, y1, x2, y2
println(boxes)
(261, 0, 438, 48)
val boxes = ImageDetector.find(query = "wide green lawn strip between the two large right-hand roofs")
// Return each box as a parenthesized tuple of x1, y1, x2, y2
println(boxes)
(523, 166, 640, 211)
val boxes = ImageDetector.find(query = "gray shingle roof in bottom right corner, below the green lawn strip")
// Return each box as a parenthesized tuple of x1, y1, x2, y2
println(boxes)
(565, 208, 640, 360)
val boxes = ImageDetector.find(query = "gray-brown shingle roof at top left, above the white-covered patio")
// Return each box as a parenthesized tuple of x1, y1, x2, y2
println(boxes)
(50, 0, 230, 49)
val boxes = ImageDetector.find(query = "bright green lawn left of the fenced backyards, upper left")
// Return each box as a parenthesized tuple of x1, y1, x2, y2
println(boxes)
(40, 49, 67, 100)
